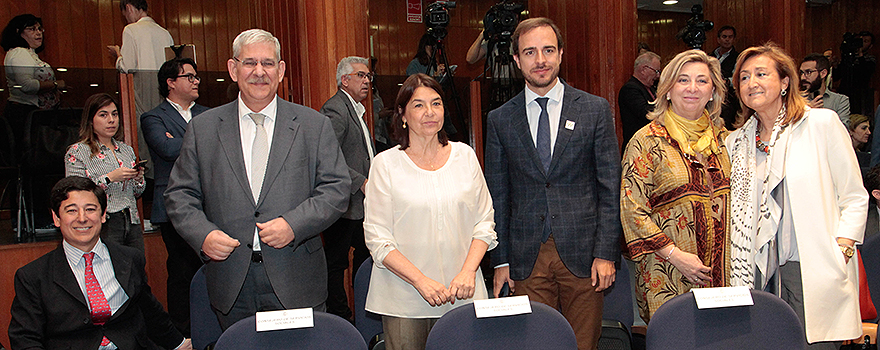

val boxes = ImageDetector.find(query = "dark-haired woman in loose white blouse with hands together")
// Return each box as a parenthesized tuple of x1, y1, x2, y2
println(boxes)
(364, 74, 498, 350)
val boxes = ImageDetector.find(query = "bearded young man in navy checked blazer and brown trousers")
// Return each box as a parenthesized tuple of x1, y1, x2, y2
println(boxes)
(486, 18, 621, 349)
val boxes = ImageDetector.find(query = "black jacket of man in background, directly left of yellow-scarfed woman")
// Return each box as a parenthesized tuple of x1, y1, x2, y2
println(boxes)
(617, 77, 656, 148)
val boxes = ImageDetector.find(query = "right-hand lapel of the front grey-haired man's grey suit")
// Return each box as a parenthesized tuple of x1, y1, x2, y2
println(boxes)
(257, 98, 299, 207)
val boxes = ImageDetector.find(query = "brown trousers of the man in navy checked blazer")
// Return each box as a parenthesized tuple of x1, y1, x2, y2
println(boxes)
(514, 235, 604, 350)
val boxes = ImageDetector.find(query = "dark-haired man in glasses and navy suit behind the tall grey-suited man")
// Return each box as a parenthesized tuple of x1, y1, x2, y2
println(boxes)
(141, 58, 208, 337)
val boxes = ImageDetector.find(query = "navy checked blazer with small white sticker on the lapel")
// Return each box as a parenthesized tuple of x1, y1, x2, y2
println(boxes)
(486, 84, 622, 280)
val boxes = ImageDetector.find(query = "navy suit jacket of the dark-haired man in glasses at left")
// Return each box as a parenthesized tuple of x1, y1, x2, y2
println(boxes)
(141, 100, 209, 222)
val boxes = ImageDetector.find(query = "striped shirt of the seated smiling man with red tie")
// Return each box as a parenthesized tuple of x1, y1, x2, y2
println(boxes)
(61, 238, 128, 350)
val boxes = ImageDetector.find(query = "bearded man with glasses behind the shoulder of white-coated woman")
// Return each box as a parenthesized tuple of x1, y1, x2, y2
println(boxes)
(800, 53, 850, 126)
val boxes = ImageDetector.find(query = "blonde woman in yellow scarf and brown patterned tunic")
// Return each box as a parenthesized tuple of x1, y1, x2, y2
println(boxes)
(620, 50, 730, 322)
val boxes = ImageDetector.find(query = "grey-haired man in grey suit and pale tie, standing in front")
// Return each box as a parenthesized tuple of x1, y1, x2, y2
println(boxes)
(165, 29, 351, 329)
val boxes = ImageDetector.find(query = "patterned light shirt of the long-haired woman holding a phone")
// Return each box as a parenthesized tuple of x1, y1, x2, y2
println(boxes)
(64, 140, 146, 224)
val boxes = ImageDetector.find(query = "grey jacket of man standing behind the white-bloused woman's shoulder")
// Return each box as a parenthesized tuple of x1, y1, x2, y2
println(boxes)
(320, 90, 376, 220)
